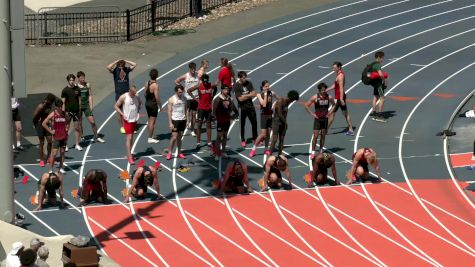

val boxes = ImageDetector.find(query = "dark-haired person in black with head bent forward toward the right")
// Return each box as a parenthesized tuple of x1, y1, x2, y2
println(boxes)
(270, 90, 300, 155)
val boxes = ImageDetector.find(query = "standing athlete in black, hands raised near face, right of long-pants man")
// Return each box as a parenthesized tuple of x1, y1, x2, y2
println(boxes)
(249, 80, 279, 158)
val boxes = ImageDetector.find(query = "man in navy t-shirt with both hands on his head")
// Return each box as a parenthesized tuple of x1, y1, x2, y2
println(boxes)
(106, 59, 137, 133)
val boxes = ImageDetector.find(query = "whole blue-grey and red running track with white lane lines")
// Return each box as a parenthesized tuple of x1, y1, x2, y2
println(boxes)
(16, 0, 475, 266)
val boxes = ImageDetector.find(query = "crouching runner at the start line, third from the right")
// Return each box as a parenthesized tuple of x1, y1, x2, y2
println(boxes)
(262, 155, 292, 191)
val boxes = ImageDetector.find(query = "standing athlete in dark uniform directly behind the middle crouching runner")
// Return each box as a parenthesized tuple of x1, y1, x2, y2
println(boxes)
(213, 84, 236, 160)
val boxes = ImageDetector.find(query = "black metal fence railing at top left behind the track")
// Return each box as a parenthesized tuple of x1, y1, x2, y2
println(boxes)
(25, 0, 240, 44)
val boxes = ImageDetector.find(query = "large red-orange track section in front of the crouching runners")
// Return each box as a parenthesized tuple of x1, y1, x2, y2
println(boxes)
(87, 180, 475, 266)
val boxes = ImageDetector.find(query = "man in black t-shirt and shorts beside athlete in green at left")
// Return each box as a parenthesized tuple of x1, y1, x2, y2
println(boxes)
(61, 74, 82, 151)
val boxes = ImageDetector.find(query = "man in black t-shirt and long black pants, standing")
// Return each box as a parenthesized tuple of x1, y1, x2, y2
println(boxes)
(233, 71, 257, 147)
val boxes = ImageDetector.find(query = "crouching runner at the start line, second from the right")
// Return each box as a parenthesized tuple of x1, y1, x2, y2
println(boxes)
(308, 153, 340, 187)
